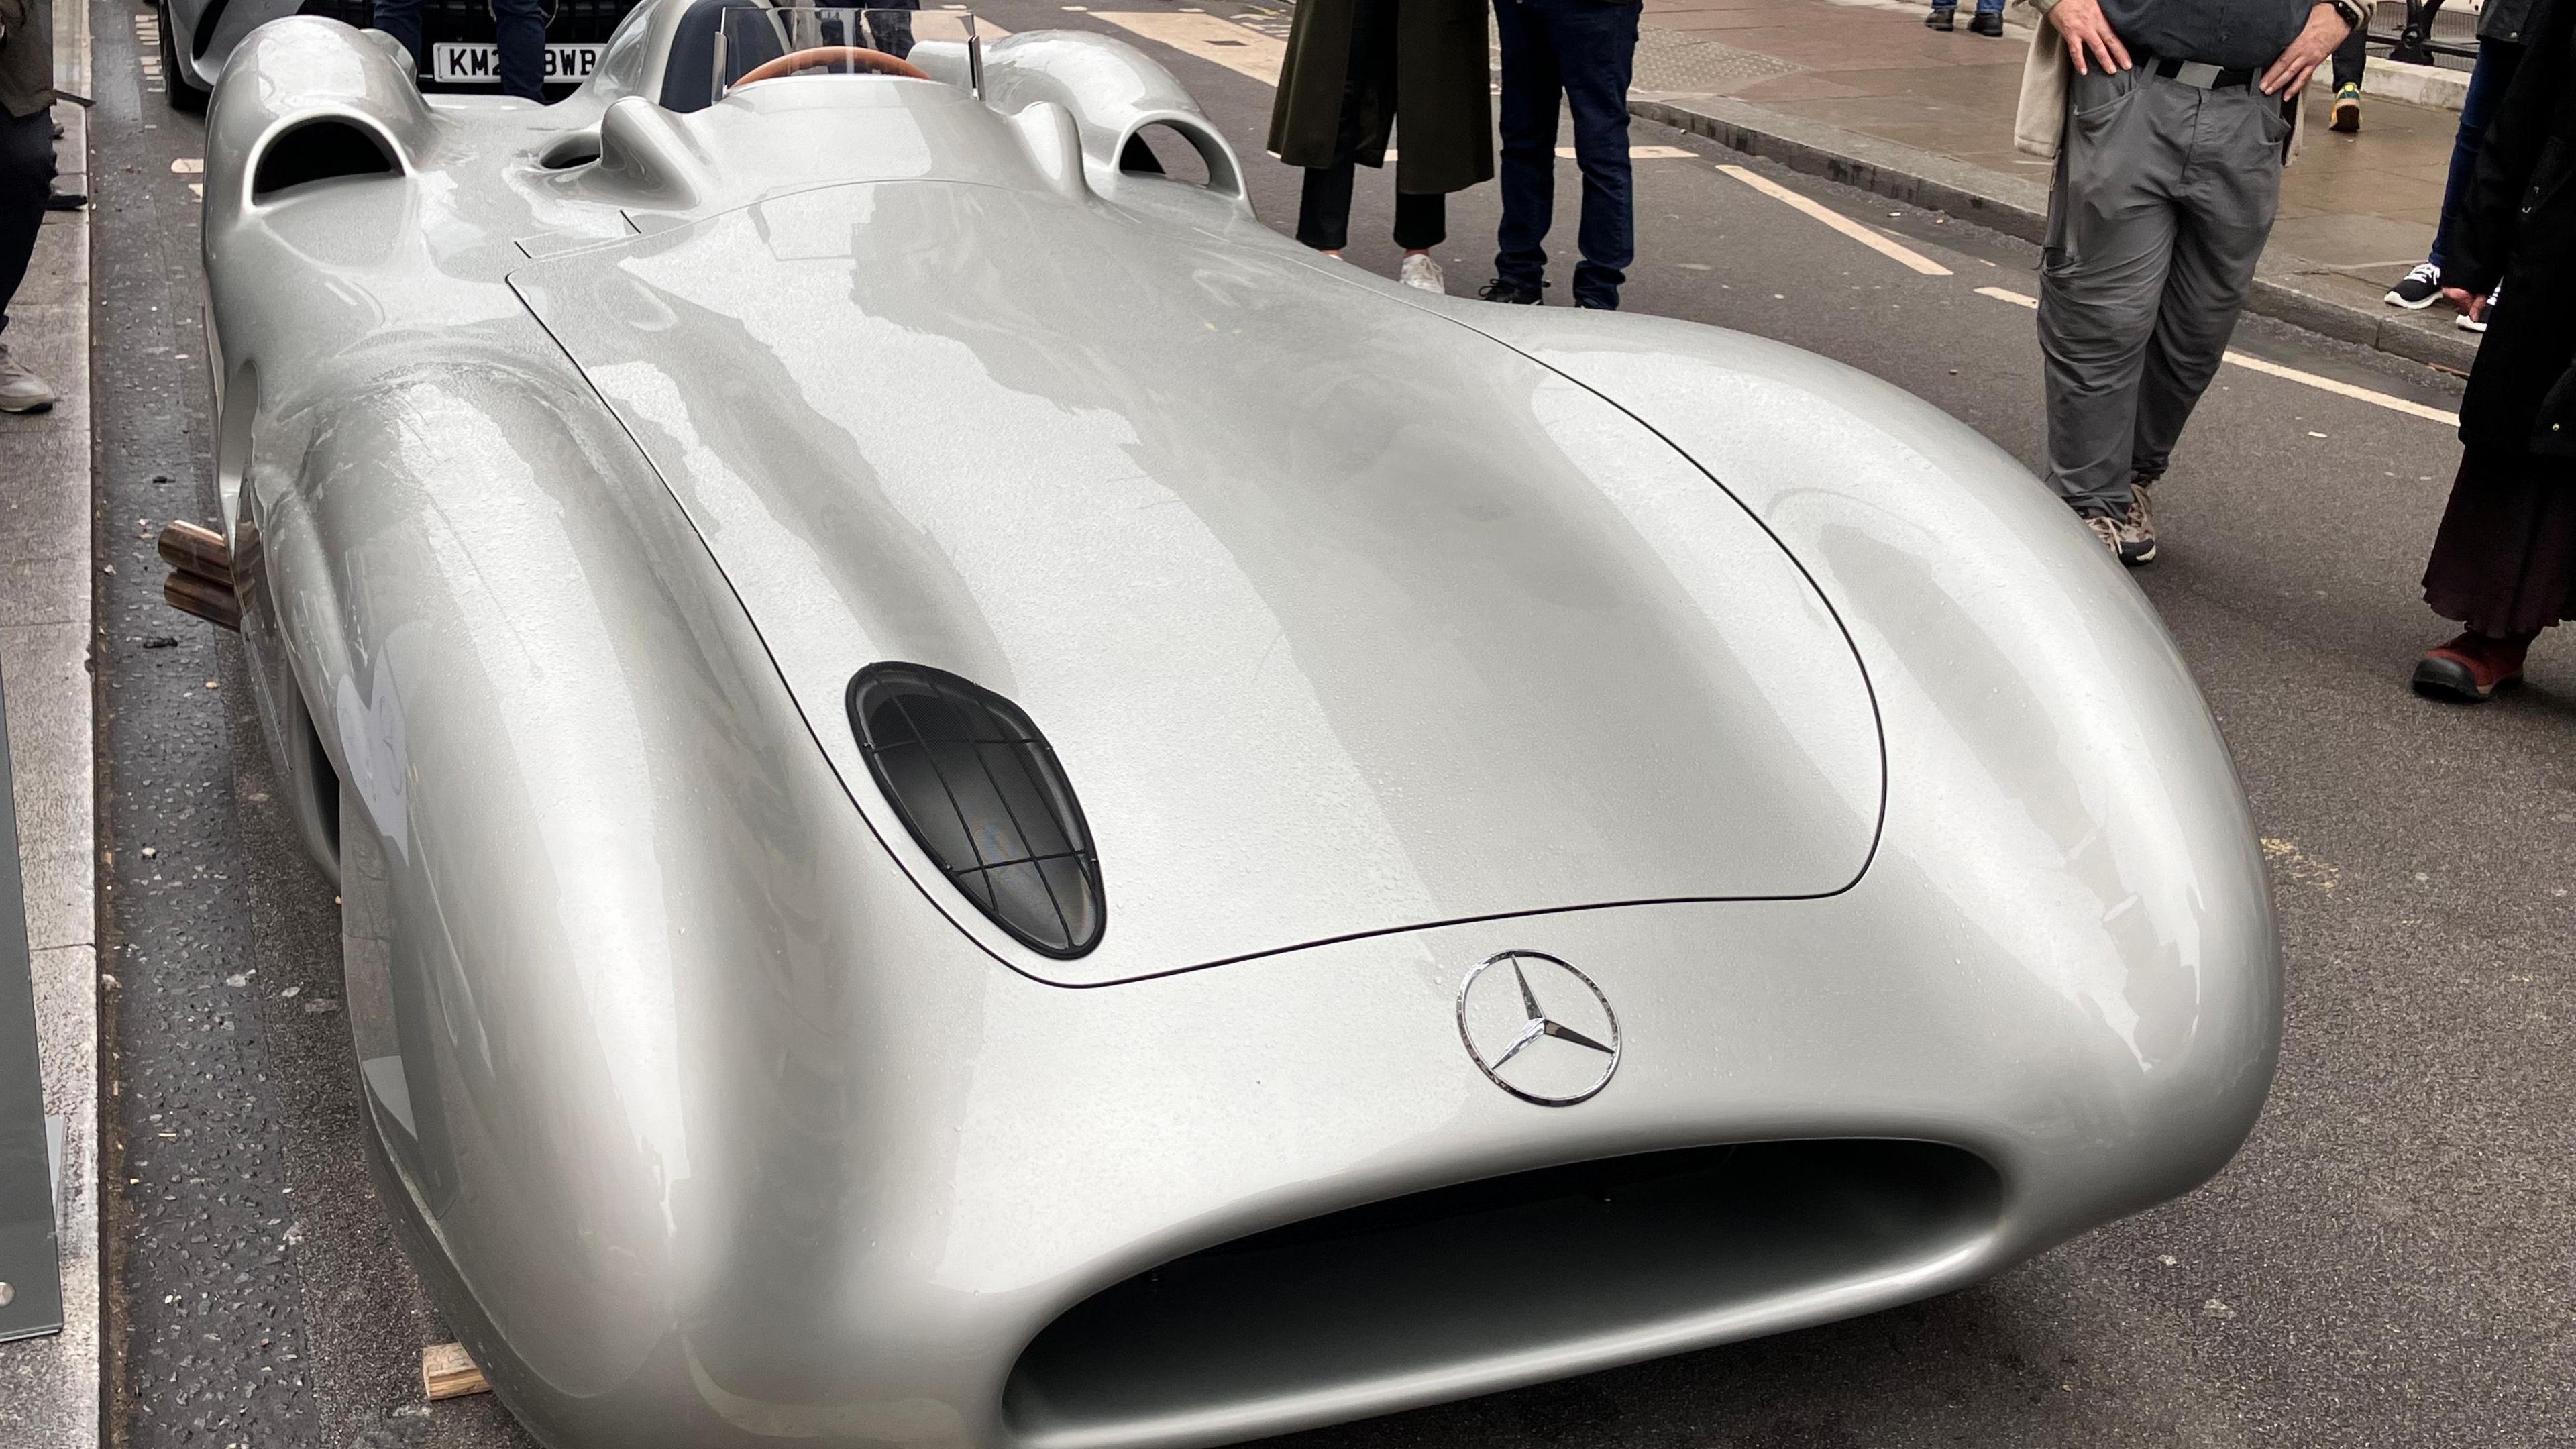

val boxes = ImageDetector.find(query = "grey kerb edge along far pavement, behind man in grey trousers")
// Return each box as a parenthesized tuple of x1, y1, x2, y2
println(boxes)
(1628, 93, 2478, 371)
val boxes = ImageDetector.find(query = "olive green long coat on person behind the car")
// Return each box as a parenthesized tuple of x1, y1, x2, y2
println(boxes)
(1270, 0, 1494, 193)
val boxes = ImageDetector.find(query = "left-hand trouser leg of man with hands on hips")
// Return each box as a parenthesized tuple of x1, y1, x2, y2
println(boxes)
(2040, 70, 2198, 519)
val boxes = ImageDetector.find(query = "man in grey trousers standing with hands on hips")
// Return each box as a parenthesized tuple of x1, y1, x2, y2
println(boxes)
(2015, 0, 2362, 565)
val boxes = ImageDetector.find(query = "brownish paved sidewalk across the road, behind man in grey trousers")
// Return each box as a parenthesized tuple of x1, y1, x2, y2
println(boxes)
(1631, 0, 2475, 369)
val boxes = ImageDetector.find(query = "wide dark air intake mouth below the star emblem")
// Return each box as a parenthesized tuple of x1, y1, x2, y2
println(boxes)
(1002, 1140, 2004, 1449)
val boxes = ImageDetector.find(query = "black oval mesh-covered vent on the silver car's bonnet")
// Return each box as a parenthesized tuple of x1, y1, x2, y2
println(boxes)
(850, 663, 1108, 959)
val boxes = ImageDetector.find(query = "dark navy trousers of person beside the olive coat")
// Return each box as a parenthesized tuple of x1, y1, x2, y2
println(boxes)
(1494, 0, 1641, 307)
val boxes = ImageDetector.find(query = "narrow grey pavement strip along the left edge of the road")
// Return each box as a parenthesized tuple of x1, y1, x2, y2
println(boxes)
(0, 0, 103, 1423)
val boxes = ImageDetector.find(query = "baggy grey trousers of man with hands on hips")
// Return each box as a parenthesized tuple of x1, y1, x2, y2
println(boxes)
(2040, 70, 2290, 513)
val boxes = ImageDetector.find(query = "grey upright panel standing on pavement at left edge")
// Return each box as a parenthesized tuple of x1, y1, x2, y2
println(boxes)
(0, 655, 62, 1343)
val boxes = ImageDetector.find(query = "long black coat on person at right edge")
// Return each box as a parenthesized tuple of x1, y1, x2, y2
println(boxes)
(2442, 0, 2576, 459)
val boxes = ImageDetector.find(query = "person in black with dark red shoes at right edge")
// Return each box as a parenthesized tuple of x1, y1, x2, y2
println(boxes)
(2414, 0, 2576, 701)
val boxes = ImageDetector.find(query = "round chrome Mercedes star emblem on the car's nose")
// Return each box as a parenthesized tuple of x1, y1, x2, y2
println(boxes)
(1458, 951, 1618, 1106)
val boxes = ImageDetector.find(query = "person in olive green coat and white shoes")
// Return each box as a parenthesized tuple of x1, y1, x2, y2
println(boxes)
(1270, 0, 1494, 291)
